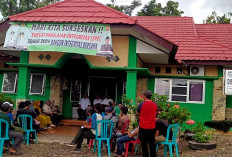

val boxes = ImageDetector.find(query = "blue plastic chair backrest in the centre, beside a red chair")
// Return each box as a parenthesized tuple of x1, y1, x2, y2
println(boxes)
(96, 120, 114, 140)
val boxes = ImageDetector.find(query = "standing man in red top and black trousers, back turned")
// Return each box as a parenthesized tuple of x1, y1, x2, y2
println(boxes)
(137, 90, 158, 157)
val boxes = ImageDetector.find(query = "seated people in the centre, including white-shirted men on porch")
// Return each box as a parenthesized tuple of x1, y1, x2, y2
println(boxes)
(67, 94, 172, 157)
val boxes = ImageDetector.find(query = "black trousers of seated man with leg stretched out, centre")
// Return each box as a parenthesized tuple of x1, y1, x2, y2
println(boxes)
(72, 128, 95, 148)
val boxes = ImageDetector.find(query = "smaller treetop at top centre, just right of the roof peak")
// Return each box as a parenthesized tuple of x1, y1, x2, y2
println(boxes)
(106, 0, 142, 16)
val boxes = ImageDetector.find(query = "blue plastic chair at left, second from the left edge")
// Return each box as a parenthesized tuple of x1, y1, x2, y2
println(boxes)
(18, 114, 38, 145)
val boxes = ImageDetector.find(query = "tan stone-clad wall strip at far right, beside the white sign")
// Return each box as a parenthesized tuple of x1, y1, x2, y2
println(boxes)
(212, 77, 226, 120)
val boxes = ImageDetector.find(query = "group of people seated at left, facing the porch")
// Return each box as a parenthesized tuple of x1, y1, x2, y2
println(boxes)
(0, 100, 62, 155)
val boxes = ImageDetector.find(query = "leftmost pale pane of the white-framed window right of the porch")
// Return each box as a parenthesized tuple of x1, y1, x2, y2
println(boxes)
(156, 79, 170, 95)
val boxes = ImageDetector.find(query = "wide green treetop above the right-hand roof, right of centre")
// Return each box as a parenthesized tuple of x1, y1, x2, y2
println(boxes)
(138, 0, 184, 16)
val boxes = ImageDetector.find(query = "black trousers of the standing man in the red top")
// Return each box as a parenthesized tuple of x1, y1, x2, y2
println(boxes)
(139, 128, 156, 157)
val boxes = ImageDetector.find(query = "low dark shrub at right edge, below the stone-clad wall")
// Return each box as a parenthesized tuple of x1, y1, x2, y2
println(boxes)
(205, 120, 232, 132)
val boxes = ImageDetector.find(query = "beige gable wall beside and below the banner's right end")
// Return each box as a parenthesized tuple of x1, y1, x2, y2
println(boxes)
(85, 36, 129, 67)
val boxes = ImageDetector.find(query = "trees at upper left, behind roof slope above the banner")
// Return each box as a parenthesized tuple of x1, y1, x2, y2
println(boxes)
(0, 0, 61, 19)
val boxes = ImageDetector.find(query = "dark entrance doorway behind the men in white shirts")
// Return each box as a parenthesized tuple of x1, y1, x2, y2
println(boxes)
(89, 77, 117, 102)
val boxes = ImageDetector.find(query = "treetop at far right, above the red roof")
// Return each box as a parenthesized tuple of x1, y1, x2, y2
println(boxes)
(203, 11, 232, 24)
